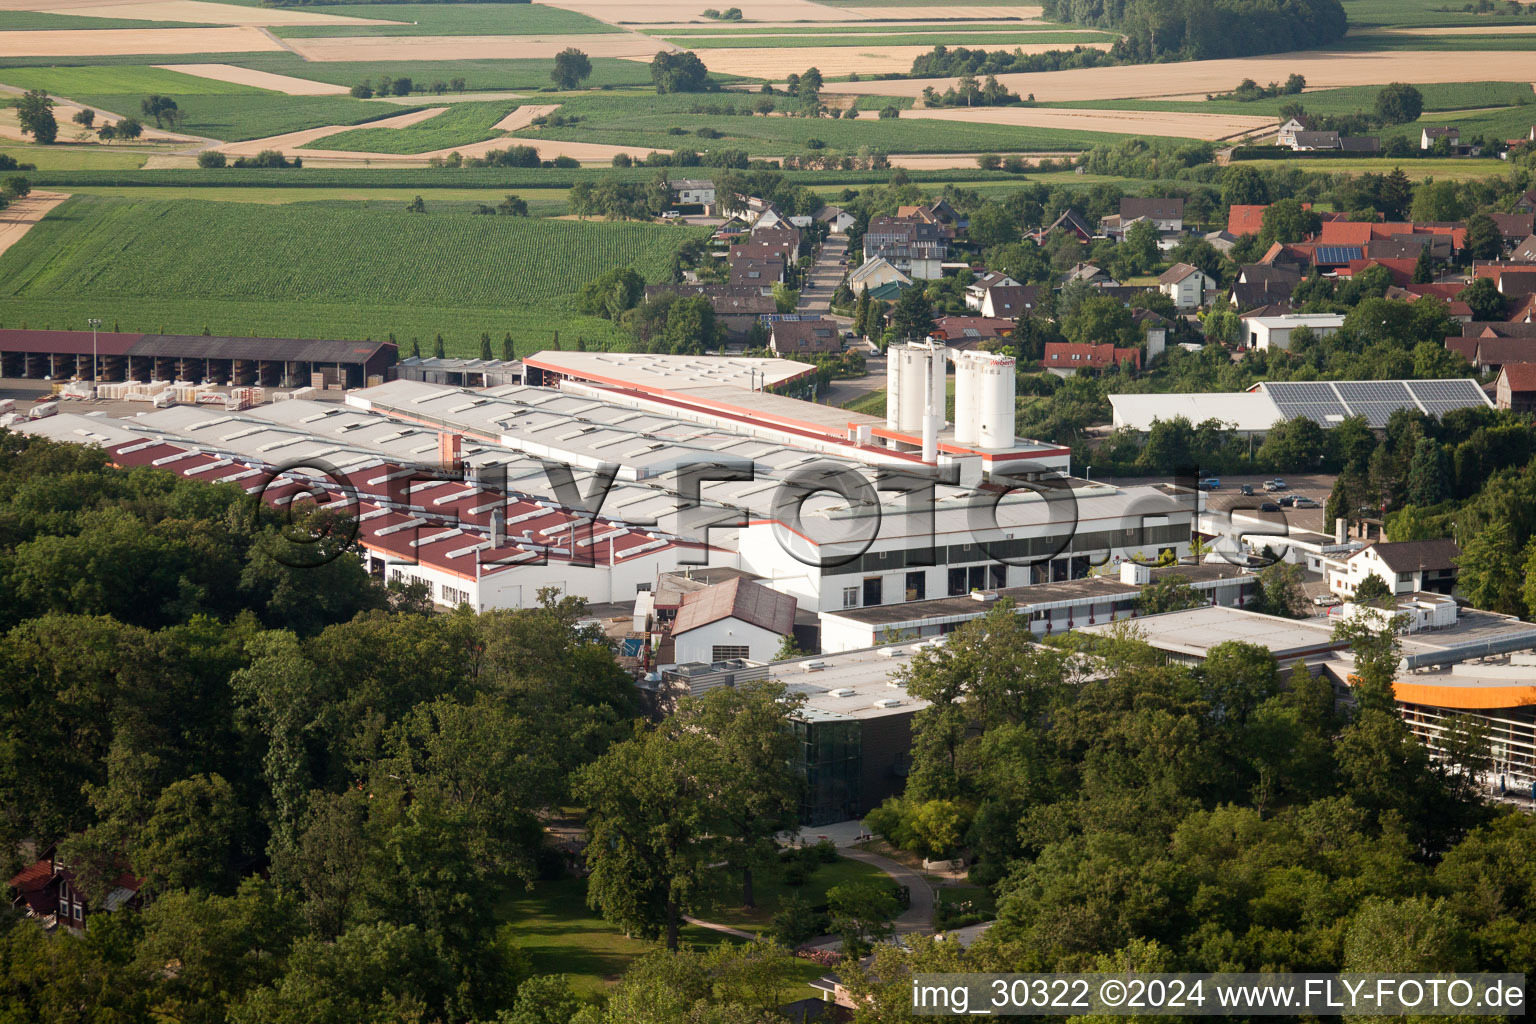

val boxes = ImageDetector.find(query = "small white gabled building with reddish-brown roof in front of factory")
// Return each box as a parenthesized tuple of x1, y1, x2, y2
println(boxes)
(671, 577, 796, 665)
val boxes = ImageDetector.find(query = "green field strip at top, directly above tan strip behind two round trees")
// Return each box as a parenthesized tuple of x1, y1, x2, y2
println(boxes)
(272, 3, 621, 38)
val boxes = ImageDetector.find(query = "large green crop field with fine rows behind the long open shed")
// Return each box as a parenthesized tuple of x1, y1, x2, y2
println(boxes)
(0, 197, 702, 355)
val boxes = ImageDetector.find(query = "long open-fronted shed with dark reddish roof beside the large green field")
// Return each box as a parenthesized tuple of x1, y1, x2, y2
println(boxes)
(0, 330, 396, 388)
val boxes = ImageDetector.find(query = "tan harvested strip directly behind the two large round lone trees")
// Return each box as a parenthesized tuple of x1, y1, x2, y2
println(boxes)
(287, 32, 671, 63)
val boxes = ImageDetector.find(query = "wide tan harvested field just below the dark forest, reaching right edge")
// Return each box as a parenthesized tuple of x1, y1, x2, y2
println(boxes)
(823, 49, 1536, 103)
